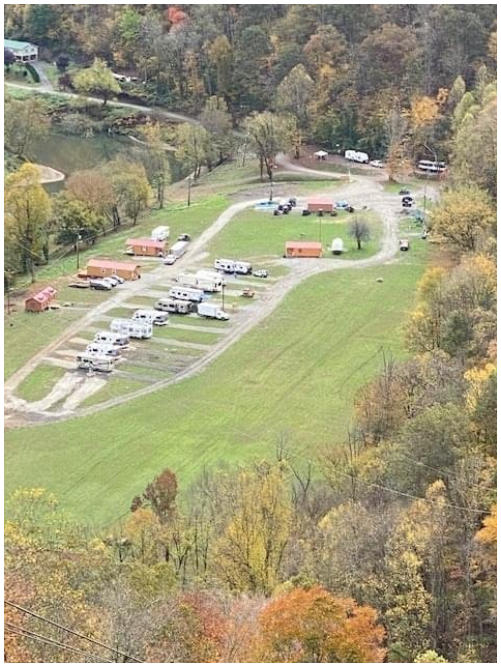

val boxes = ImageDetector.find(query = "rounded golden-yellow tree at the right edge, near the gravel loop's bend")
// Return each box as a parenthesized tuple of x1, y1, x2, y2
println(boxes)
(430, 185, 496, 252)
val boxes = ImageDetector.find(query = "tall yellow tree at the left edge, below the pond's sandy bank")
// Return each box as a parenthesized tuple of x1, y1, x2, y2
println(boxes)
(4, 162, 51, 282)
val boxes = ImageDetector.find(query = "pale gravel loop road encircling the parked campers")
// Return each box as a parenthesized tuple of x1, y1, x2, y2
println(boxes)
(5, 175, 436, 423)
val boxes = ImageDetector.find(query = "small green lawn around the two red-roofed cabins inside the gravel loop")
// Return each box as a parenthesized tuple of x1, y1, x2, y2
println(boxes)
(208, 210, 381, 260)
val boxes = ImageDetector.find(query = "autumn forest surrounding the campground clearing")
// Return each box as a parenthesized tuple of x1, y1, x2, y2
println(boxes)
(5, 4, 497, 663)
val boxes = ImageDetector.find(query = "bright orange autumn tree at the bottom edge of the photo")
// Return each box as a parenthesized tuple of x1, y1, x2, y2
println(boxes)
(257, 586, 386, 663)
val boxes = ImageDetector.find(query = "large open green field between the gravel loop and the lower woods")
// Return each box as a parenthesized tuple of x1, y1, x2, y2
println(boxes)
(5, 241, 427, 525)
